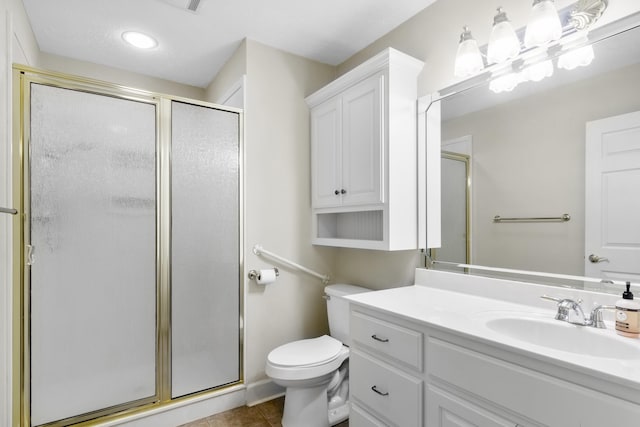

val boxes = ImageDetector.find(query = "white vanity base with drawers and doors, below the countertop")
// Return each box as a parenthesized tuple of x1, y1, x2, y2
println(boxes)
(349, 302, 640, 427)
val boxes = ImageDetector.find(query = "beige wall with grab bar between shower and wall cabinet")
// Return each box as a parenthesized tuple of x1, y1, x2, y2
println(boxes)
(214, 40, 335, 383)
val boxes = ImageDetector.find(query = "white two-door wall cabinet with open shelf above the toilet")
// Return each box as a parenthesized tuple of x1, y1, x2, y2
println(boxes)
(306, 48, 423, 250)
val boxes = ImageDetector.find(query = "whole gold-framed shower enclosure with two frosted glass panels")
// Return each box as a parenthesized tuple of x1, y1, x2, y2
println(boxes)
(14, 67, 242, 426)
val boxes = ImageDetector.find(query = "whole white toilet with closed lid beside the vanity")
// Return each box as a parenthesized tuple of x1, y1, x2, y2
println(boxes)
(266, 284, 370, 427)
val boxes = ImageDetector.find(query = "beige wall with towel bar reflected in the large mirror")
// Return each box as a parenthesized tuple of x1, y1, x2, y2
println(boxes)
(438, 23, 640, 275)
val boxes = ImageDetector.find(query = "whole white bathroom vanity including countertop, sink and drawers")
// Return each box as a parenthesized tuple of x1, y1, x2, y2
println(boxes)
(349, 269, 640, 427)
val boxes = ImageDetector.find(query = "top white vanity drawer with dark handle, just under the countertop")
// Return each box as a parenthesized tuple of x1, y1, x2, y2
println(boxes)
(350, 311, 422, 371)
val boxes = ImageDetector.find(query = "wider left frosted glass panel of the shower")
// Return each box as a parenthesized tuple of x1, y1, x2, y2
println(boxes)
(28, 83, 157, 425)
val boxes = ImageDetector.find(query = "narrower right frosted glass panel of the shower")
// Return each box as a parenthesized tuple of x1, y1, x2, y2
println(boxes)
(171, 101, 240, 397)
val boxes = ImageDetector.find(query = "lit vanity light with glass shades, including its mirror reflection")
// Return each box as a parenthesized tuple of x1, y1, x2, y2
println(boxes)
(454, 0, 609, 92)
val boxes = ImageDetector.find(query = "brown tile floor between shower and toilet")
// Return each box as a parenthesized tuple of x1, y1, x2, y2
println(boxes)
(181, 397, 349, 427)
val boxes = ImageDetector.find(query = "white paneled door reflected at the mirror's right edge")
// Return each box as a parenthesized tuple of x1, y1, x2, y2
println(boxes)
(585, 111, 640, 289)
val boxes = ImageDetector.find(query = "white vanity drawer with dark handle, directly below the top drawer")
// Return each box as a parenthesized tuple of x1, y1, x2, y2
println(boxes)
(349, 350, 422, 427)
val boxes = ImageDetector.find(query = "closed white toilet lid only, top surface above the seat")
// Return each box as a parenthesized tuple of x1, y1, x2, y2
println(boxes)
(267, 335, 342, 366)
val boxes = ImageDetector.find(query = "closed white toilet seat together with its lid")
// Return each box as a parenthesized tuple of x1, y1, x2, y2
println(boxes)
(266, 335, 349, 382)
